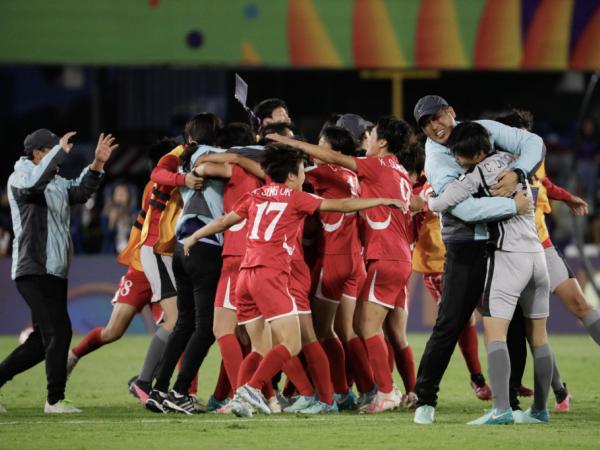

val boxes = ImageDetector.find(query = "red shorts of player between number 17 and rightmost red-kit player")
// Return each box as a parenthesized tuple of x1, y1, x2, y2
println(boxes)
(313, 253, 367, 303)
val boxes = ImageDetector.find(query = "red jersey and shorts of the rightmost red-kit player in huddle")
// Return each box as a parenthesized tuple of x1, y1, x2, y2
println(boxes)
(354, 155, 412, 308)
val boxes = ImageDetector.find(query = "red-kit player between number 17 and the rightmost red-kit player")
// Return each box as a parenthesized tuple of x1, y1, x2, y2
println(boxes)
(306, 126, 374, 410)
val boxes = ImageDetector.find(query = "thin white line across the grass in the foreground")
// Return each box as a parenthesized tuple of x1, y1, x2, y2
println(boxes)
(0, 416, 404, 426)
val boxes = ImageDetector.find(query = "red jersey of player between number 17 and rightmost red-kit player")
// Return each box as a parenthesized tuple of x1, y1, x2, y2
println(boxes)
(306, 164, 361, 255)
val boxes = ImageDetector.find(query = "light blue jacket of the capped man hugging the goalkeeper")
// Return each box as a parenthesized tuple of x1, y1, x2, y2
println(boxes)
(425, 120, 544, 242)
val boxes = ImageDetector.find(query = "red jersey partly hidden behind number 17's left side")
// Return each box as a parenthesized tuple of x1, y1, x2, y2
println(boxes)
(223, 164, 262, 256)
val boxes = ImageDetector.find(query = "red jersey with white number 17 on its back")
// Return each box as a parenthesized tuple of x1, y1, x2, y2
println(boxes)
(233, 183, 323, 273)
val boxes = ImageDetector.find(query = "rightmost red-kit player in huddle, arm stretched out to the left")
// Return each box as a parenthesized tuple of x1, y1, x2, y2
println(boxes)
(268, 117, 412, 413)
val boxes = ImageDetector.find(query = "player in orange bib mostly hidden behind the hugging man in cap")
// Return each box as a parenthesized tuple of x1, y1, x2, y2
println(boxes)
(400, 142, 492, 400)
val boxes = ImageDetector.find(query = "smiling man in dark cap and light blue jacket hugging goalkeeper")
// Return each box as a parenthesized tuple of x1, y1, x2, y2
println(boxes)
(414, 95, 544, 424)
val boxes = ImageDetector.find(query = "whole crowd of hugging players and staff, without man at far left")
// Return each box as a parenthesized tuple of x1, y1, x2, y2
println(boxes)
(2, 92, 600, 424)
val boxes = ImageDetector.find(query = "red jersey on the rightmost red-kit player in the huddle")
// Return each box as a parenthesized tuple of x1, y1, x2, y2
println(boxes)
(354, 155, 412, 262)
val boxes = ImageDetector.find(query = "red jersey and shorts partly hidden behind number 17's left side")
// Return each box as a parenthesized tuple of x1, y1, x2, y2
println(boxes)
(215, 164, 262, 311)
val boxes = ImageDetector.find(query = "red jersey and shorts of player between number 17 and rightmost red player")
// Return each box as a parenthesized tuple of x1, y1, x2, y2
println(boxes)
(306, 164, 366, 303)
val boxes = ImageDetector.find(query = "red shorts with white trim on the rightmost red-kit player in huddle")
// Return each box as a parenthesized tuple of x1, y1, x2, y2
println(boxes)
(358, 260, 412, 309)
